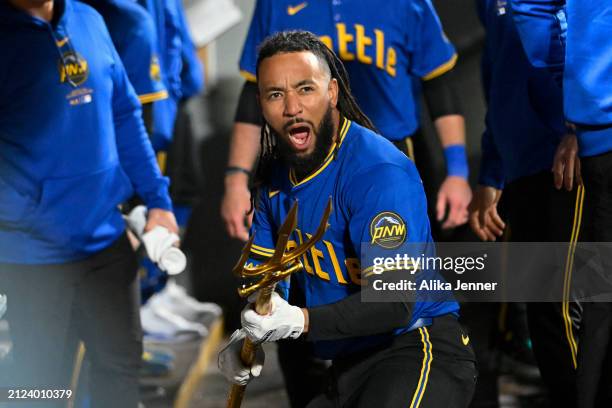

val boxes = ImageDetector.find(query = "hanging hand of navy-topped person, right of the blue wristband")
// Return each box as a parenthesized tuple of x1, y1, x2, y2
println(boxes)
(469, 185, 506, 241)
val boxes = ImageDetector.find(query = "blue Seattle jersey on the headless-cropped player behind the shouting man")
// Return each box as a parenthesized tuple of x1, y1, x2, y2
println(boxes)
(240, 0, 457, 140)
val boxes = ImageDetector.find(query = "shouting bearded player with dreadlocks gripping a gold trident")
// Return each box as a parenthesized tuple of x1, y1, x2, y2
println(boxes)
(219, 31, 475, 407)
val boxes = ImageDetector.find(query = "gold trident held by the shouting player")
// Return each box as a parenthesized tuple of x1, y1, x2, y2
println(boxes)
(227, 197, 332, 408)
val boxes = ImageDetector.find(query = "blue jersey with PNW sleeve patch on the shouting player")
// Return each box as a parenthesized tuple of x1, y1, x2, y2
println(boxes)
(246, 119, 458, 358)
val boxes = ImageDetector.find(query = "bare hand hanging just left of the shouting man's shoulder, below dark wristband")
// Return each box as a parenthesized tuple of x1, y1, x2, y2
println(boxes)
(221, 173, 253, 241)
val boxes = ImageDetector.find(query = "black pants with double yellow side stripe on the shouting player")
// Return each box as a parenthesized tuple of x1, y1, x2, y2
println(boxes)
(308, 315, 477, 408)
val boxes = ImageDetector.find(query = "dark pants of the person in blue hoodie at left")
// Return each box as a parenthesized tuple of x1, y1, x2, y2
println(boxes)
(0, 236, 142, 408)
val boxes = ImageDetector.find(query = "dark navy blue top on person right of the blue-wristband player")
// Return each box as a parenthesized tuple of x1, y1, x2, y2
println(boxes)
(477, 0, 565, 188)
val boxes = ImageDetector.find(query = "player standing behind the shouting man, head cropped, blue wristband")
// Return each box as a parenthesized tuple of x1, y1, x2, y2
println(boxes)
(221, 0, 471, 240)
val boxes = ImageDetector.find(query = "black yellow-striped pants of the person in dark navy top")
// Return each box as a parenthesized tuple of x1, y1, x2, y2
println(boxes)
(503, 172, 582, 407)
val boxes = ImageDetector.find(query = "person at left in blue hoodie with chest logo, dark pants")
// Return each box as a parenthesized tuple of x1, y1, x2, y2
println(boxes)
(0, 0, 178, 407)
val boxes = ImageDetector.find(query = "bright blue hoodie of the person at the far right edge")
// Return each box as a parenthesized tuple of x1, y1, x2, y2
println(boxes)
(512, 0, 612, 156)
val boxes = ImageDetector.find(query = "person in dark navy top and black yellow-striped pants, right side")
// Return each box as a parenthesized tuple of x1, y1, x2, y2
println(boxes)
(470, 0, 583, 407)
